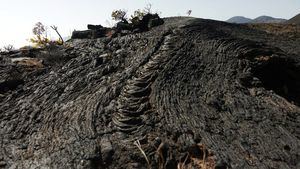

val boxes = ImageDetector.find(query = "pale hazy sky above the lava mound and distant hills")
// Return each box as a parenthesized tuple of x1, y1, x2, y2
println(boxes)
(0, 0, 300, 47)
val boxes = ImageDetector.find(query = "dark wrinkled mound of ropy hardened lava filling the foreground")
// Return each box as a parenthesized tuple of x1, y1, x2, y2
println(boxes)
(0, 18, 300, 169)
